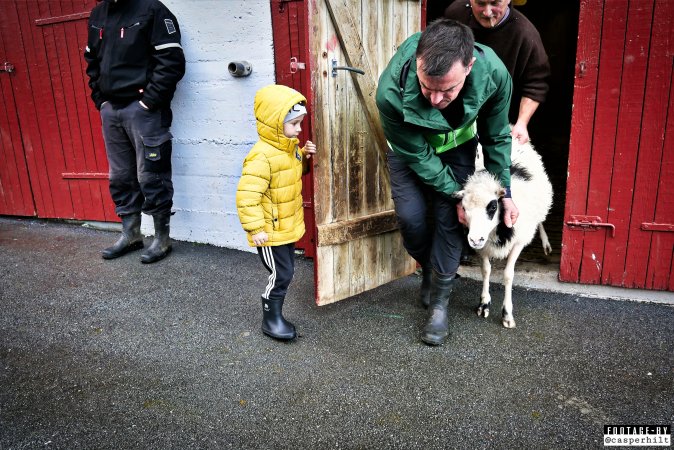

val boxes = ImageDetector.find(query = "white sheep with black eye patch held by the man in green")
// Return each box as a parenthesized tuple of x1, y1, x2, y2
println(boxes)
(455, 140, 552, 328)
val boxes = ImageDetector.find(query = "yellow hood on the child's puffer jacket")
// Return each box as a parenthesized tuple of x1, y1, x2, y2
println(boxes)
(255, 84, 307, 152)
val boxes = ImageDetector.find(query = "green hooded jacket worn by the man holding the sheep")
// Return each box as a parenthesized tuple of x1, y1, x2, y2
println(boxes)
(376, 33, 512, 195)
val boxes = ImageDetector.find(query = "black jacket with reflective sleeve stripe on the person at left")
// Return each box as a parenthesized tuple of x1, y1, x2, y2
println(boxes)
(84, 0, 185, 109)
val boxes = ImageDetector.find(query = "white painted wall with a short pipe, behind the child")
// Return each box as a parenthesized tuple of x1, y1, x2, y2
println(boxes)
(142, 0, 275, 250)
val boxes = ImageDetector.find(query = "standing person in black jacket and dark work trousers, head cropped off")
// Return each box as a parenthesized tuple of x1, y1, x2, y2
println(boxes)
(84, 0, 185, 263)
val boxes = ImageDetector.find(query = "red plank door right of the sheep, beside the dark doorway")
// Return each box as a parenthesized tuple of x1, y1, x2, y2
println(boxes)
(560, 0, 674, 290)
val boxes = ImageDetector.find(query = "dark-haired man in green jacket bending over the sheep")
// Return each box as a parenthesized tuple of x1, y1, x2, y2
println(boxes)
(377, 19, 518, 345)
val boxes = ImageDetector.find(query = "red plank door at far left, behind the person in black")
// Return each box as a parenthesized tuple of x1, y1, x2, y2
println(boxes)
(0, 0, 117, 221)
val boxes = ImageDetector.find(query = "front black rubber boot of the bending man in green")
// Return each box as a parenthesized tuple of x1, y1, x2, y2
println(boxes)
(421, 271, 456, 345)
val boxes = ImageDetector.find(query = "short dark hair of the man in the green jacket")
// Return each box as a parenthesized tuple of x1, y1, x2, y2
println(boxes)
(416, 18, 475, 77)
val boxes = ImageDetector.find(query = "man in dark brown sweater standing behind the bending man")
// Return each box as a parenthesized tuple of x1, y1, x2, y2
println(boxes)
(445, 0, 550, 144)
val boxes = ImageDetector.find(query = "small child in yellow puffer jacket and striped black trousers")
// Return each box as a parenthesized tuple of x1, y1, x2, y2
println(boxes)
(236, 84, 316, 340)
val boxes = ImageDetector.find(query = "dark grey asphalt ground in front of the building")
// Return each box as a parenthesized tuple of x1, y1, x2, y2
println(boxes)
(0, 217, 674, 449)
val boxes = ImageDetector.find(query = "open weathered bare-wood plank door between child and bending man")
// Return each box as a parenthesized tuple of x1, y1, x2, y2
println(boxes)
(309, 0, 423, 305)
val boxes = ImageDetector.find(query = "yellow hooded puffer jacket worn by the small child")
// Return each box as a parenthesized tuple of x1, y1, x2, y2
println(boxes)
(236, 85, 306, 247)
